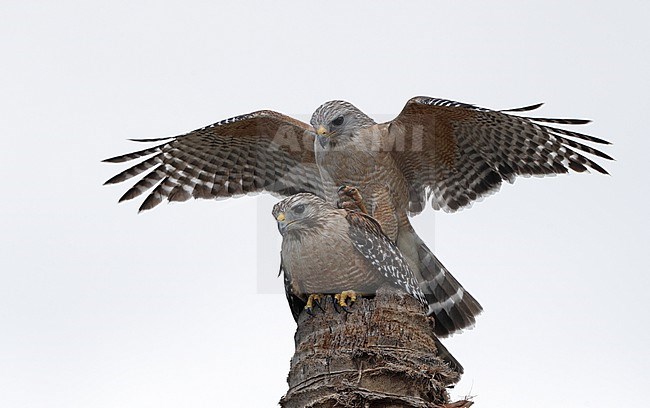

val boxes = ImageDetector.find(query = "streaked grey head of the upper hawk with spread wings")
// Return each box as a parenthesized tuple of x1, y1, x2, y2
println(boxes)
(310, 101, 376, 148)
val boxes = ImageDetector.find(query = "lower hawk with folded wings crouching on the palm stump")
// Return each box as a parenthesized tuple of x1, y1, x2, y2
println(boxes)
(272, 193, 464, 374)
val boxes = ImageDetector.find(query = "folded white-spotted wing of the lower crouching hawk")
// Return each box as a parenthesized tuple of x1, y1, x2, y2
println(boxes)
(346, 211, 427, 305)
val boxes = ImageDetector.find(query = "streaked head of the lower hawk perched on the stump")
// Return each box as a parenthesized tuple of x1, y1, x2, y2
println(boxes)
(272, 193, 334, 236)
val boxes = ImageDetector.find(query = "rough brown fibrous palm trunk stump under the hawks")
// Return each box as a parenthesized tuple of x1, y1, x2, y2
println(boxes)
(280, 292, 472, 408)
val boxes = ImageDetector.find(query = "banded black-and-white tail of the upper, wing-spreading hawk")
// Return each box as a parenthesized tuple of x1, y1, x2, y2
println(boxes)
(398, 227, 483, 337)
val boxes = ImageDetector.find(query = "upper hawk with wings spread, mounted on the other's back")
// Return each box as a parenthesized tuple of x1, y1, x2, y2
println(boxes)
(106, 97, 611, 332)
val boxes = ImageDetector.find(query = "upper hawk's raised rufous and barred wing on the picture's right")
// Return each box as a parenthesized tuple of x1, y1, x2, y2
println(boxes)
(388, 96, 612, 214)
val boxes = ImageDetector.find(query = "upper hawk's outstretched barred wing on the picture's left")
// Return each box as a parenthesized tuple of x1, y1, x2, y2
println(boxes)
(104, 111, 323, 211)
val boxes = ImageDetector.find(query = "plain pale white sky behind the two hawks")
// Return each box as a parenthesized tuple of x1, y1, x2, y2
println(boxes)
(0, 0, 650, 408)
